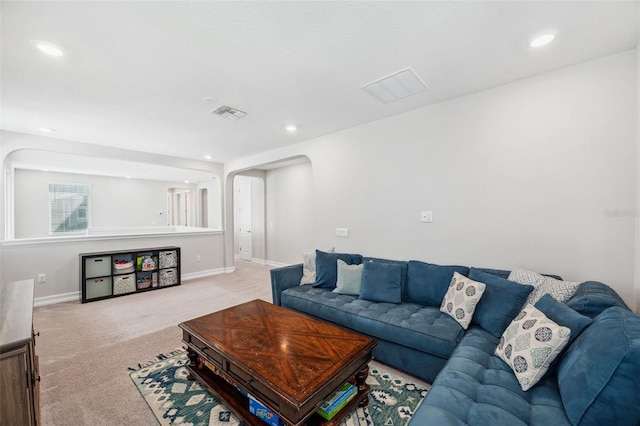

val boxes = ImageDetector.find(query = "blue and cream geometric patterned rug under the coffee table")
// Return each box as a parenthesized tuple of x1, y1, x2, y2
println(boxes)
(130, 350, 431, 426)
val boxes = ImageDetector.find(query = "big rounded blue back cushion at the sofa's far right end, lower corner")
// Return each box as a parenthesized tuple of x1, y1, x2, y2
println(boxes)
(558, 307, 640, 425)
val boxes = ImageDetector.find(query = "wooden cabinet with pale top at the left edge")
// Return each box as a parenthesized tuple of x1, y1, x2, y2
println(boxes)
(0, 280, 40, 426)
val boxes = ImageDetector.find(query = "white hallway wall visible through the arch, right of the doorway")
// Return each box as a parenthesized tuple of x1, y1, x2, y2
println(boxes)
(266, 162, 315, 264)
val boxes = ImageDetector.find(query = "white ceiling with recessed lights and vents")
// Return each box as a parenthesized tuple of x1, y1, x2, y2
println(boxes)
(1, 1, 639, 170)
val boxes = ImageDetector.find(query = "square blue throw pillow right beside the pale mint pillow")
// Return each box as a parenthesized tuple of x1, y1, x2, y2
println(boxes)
(360, 262, 402, 303)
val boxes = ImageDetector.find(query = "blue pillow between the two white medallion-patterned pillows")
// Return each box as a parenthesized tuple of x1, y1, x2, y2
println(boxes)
(469, 268, 533, 338)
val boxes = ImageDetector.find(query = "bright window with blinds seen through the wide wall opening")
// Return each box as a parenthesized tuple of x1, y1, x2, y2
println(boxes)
(49, 183, 89, 234)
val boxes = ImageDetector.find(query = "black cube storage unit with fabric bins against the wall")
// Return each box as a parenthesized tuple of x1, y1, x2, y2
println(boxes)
(80, 247, 180, 303)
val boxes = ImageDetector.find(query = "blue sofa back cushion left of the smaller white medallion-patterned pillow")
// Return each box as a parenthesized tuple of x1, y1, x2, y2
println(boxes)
(405, 260, 469, 307)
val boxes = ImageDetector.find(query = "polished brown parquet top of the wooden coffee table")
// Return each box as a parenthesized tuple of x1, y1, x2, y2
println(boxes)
(180, 300, 376, 403)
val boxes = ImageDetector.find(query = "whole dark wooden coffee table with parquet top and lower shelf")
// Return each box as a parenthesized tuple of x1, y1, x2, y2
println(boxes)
(179, 300, 377, 425)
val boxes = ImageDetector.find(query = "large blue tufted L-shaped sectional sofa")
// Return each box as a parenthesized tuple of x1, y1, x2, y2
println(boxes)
(271, 252, 640, 426)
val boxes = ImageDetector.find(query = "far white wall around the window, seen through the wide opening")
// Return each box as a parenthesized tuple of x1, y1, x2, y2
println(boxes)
(14, 169, 197, 238)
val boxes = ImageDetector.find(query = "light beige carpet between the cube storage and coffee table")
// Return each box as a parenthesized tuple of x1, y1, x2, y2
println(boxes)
(34, 261, 271, 426)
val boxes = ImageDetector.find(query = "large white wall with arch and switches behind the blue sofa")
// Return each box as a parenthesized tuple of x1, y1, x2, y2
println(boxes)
(225, 51, 638, 305)
